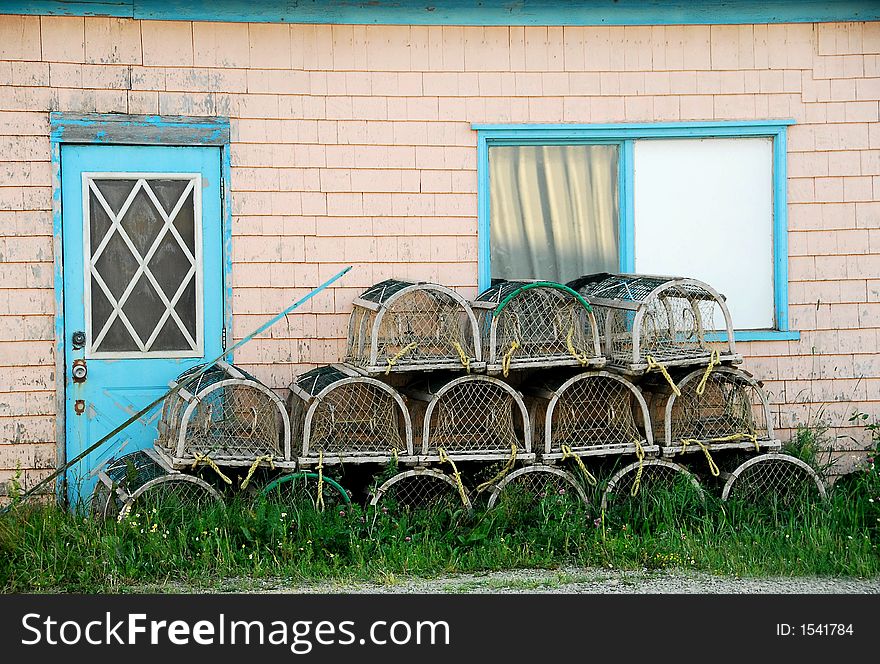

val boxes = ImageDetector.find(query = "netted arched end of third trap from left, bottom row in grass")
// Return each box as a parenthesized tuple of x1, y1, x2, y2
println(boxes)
(370, 469, 471, 512)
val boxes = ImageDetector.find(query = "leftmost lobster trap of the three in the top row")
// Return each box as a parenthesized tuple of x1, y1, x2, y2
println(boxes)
(346, 279, 484, 375)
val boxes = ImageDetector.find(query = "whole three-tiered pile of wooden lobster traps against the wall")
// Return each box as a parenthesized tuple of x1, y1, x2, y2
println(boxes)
(92, 273, 825, 519)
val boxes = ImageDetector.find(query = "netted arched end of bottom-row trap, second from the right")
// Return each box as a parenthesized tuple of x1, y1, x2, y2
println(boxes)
(602, 459, 705, 519)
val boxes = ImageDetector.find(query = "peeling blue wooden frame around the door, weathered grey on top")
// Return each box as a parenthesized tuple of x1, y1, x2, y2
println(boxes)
(49, 112, 232, 504)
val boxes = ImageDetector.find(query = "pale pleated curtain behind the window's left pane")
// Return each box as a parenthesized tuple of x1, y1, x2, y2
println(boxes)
(489, 145, 620, 283)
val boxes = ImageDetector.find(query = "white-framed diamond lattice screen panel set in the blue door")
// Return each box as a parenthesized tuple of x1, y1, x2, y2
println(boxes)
(83, 173, 202, 358)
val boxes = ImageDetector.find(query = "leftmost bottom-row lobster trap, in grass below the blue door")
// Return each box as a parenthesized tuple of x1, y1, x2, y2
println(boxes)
(90, 449, 223, 528)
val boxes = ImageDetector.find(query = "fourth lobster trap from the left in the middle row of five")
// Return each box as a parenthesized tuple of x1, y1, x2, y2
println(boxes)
(524, 371, 660, 461)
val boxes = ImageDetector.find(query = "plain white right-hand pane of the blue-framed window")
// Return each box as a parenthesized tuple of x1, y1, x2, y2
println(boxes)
(633, 138, 775, 330)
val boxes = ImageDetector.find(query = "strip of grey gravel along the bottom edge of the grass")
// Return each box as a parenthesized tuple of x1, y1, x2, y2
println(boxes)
(167, 568, 880, 594)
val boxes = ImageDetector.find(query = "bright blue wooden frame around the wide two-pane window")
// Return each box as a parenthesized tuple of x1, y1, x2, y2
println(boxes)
(472, 120, 800, 341)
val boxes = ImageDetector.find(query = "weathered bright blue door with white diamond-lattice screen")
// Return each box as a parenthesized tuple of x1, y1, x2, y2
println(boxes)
(61, 145, 223, 505)
